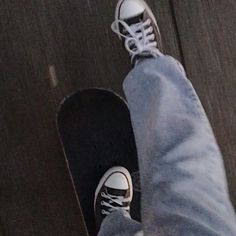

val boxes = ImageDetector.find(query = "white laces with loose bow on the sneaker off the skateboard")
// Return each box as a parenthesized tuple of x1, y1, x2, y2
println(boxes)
(111, 19, 160, 62)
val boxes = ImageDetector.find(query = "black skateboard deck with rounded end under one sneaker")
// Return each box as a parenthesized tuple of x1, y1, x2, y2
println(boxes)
(57, 89, 140, 236)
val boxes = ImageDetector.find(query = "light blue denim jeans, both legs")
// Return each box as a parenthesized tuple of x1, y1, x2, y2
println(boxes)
(98, 55, 236, 236)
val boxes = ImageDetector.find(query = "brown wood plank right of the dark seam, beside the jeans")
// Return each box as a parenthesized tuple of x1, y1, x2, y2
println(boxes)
(172, 0, 236, 207)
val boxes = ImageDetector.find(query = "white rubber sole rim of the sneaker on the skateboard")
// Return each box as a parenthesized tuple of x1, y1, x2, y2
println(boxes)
(94, 166, 133, 211)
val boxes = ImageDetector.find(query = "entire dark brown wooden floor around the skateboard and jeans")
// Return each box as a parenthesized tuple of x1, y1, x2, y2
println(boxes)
(0, 0, 236, 236)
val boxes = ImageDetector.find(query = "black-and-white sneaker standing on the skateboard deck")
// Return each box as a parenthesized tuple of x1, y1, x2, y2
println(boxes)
(94, 166, 133, 229)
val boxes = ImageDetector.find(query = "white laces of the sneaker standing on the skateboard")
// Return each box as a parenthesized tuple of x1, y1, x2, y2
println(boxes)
(101, 192, 130, 215)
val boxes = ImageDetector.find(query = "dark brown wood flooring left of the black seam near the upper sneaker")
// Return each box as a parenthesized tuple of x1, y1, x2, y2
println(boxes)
(0, 0, 180, 236)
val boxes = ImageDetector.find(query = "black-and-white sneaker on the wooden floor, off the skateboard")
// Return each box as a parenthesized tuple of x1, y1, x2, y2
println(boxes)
(111, 0, 162, 64)
